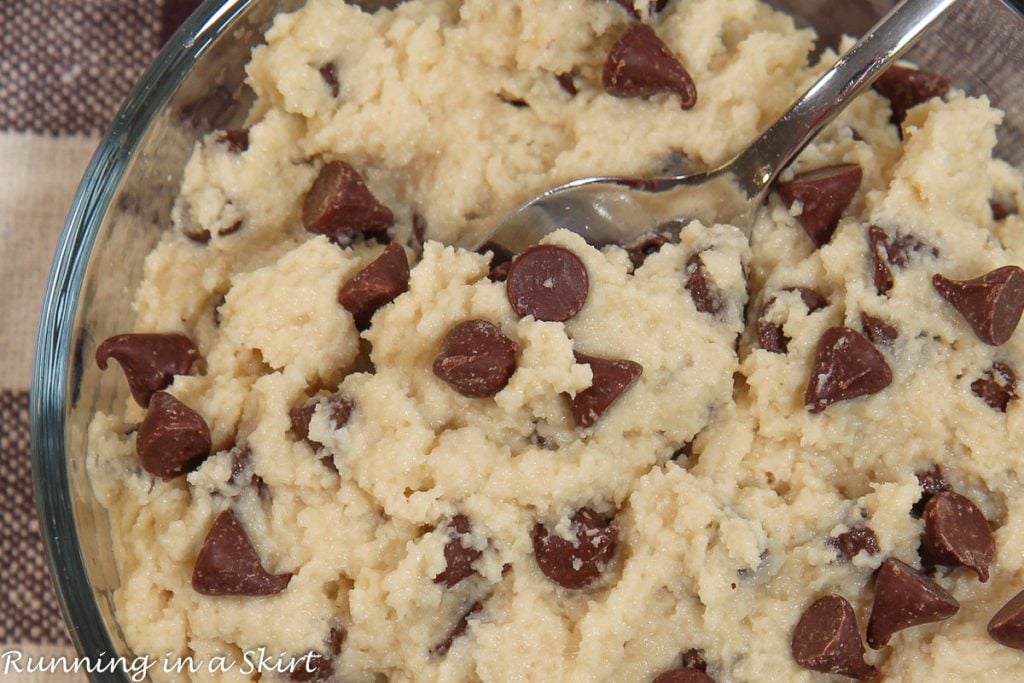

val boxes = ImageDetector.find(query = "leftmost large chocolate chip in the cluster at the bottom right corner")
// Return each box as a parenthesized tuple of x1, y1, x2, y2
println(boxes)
(792, 595, 879, 680)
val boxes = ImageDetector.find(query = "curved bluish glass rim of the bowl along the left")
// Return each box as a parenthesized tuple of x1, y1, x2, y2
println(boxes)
(29, 0, 257, 681)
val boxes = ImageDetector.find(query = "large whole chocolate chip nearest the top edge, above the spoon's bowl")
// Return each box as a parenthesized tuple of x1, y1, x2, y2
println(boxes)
(601, 24, 697, 110)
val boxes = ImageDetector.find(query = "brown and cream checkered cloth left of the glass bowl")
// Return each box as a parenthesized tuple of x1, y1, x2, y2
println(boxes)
(0, 0, 200, 681)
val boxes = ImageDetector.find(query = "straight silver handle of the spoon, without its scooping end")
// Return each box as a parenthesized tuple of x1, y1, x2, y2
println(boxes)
(728, 0, 956, 199)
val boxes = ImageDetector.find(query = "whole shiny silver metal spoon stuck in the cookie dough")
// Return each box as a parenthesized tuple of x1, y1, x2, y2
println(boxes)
(476, 0, 956, 253)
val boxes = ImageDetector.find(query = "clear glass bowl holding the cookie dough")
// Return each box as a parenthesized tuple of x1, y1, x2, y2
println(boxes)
(31, 0, 1024, 681)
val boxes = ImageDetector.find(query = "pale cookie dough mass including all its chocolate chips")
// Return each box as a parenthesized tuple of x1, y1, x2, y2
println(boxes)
(89, 0, 1024, 682)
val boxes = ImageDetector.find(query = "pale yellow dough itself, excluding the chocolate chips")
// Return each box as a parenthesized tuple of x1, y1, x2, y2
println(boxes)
(89, 0, 1024, 682)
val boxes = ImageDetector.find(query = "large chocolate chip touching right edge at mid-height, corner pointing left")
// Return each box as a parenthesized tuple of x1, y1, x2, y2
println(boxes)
(932, 265, 1024, 346)
